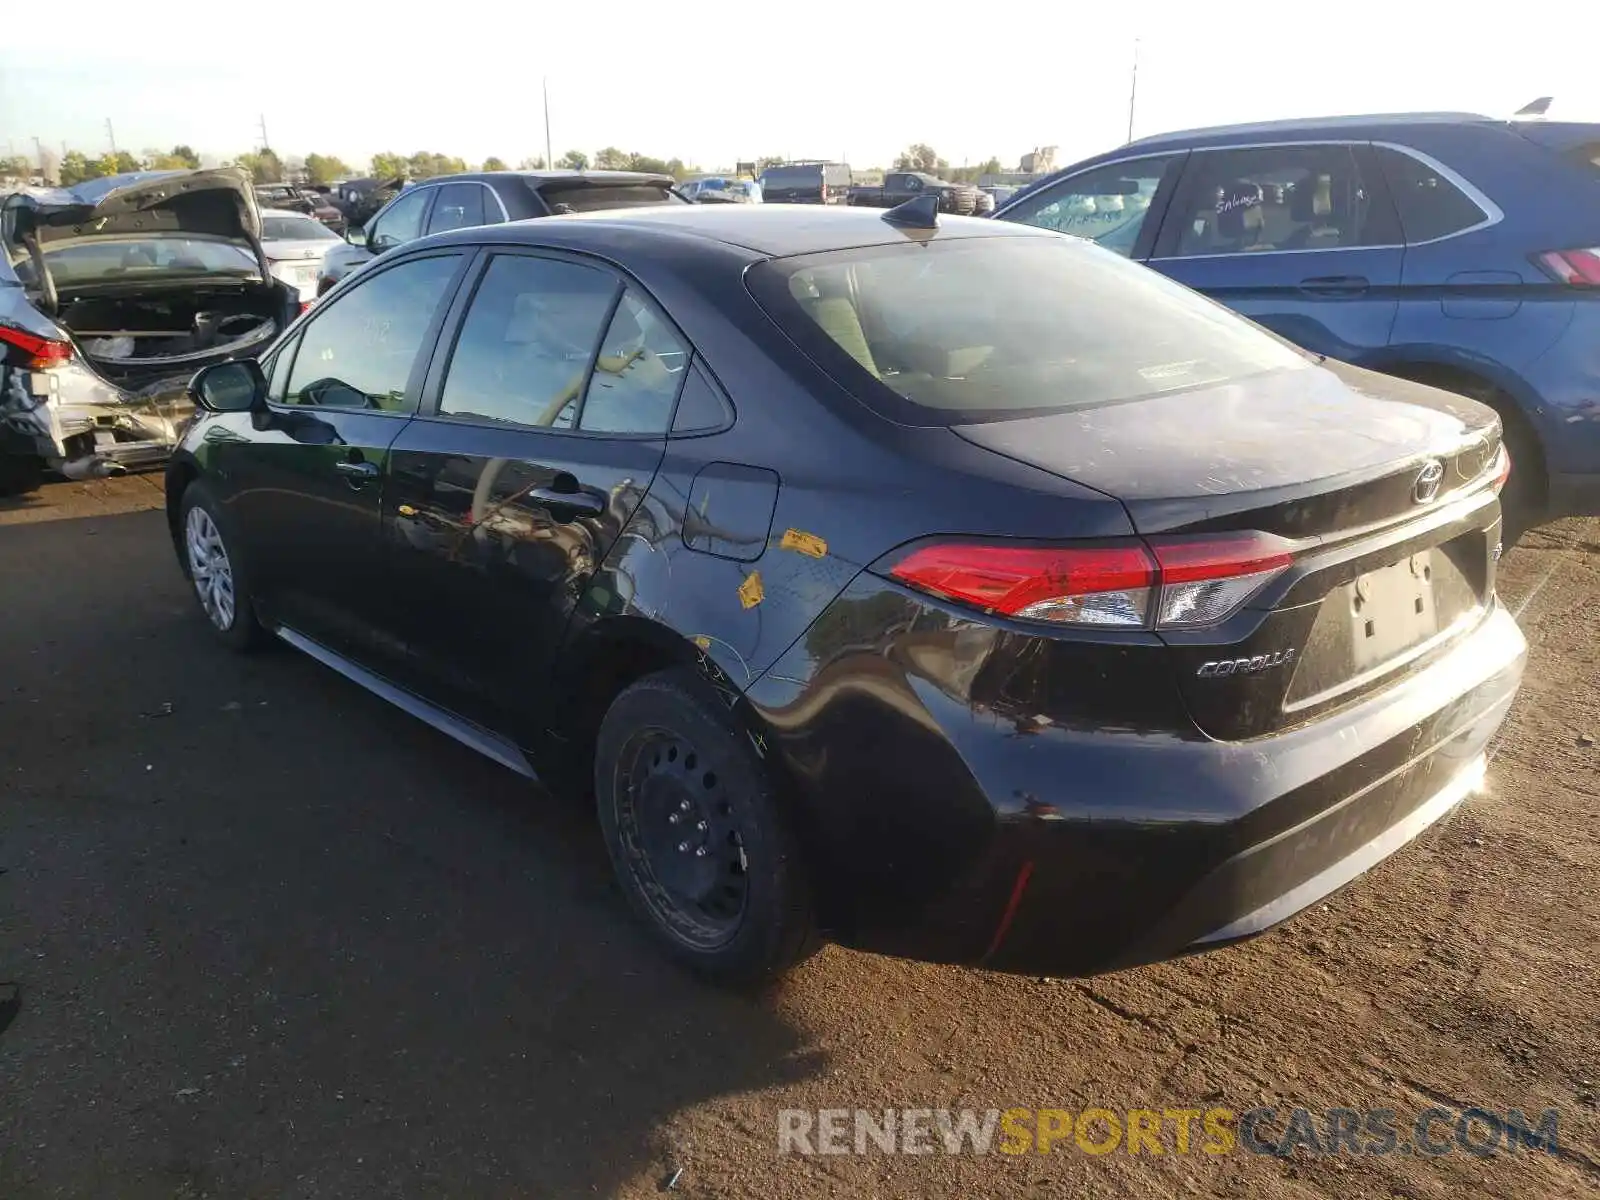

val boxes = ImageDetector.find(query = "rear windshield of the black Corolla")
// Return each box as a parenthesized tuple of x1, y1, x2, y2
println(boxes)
(747, 237, 1312, 424)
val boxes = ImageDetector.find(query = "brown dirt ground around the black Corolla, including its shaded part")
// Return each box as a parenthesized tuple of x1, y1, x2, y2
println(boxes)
(0, 477, 1600, 1200)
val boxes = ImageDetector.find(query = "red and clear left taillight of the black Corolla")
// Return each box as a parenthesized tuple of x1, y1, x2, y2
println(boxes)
(886, 533, 1294, 629)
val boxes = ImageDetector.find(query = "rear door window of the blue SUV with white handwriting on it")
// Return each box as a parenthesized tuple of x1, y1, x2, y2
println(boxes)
(1162, 144, 1394, 258)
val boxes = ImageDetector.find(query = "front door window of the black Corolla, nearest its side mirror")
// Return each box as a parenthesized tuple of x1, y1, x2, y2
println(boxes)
(283, 254, 461, 413)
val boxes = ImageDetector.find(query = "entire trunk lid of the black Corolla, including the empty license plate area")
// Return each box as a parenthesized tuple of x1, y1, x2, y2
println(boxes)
(955, 363, 1499, 739)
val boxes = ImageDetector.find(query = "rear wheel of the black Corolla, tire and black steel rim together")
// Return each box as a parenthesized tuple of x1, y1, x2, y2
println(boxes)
(594, 670, 819, 987)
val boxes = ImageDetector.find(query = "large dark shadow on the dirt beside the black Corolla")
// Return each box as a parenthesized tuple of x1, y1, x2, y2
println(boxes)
(0, 512, 822, 1197)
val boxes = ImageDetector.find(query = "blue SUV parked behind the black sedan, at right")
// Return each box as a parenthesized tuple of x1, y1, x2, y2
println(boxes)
(995, 114, 1600, 533)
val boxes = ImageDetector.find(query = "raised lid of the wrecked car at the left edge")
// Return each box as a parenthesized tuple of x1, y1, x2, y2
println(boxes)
(0, 166, 270, 278)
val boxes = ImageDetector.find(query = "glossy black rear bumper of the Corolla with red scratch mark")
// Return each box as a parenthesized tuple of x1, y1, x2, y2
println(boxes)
(755, 598, 1526, 976)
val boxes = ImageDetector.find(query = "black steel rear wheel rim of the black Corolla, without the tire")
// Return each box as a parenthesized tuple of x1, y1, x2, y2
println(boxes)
(618, 730, 747, 949)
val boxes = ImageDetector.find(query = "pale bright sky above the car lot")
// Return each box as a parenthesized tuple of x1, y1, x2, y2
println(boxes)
(0, 0, 1600, 170)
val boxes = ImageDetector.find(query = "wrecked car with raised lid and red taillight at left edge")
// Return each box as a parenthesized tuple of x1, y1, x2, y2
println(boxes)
(0, 168, 301, 491)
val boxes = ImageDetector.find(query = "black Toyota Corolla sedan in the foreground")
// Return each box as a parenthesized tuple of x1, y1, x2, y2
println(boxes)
(166, 202, 1525, 981)
